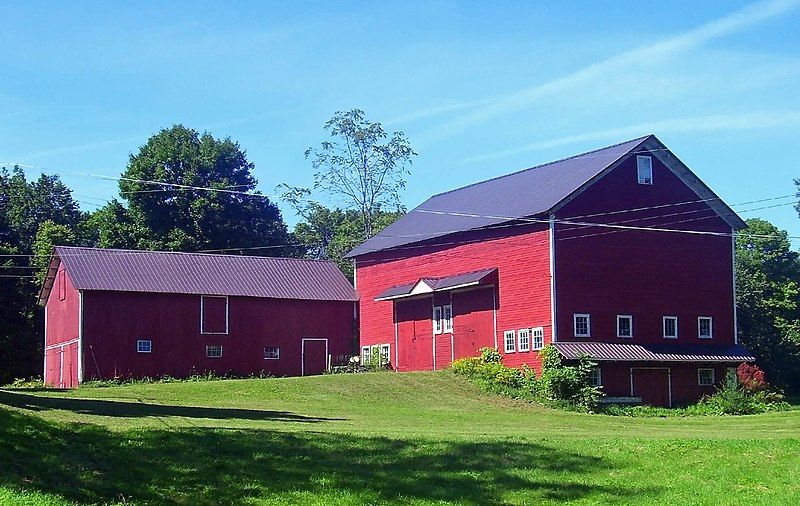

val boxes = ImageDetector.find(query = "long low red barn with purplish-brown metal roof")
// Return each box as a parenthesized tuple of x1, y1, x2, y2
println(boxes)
(40, 246, 357, 388)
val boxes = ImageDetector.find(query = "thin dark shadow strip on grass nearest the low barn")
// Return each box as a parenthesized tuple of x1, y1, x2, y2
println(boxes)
(0, 390, 341, 423)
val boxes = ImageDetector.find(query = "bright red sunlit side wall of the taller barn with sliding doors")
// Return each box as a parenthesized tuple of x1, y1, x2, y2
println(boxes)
(356, 225, 550, 370)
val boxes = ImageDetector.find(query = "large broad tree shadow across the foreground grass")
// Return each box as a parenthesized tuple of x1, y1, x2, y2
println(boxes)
(0, 408, 657, 504)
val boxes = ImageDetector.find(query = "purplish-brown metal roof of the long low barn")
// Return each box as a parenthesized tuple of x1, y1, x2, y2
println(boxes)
(40, 246, 358, 302)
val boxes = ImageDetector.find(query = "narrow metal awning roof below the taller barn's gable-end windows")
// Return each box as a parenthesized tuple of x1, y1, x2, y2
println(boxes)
(553, 342, 755, 362)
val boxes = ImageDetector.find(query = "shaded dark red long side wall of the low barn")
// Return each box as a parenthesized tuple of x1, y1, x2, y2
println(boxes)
(84, 292, 354, 378)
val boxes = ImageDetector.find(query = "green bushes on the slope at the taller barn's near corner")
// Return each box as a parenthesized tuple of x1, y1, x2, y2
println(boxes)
(453, 346, 602, 411)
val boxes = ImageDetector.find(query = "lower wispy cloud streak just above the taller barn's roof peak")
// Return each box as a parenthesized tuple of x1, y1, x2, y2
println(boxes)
(463, 111, 800, 163)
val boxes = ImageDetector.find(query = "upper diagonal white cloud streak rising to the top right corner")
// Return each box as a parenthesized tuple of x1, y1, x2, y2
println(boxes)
(422, 0, 800, 139)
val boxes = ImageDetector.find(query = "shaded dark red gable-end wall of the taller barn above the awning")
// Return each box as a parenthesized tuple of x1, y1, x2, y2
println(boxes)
(555, 152, 734, 345)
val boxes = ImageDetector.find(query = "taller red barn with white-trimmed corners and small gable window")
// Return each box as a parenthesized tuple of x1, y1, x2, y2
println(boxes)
(349, 135, 753, 405)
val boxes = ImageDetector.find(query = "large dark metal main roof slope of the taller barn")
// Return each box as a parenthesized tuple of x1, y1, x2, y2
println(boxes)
(347, 136, 651, 257)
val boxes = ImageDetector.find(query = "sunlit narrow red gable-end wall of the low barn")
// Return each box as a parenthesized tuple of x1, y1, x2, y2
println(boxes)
(43, 263, 80, 388)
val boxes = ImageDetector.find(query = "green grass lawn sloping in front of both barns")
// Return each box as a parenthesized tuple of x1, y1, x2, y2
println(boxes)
(0, 372, 800, 505)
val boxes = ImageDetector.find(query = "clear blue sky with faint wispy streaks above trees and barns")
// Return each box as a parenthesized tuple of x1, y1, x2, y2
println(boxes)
(0, 0, 800, 241)
